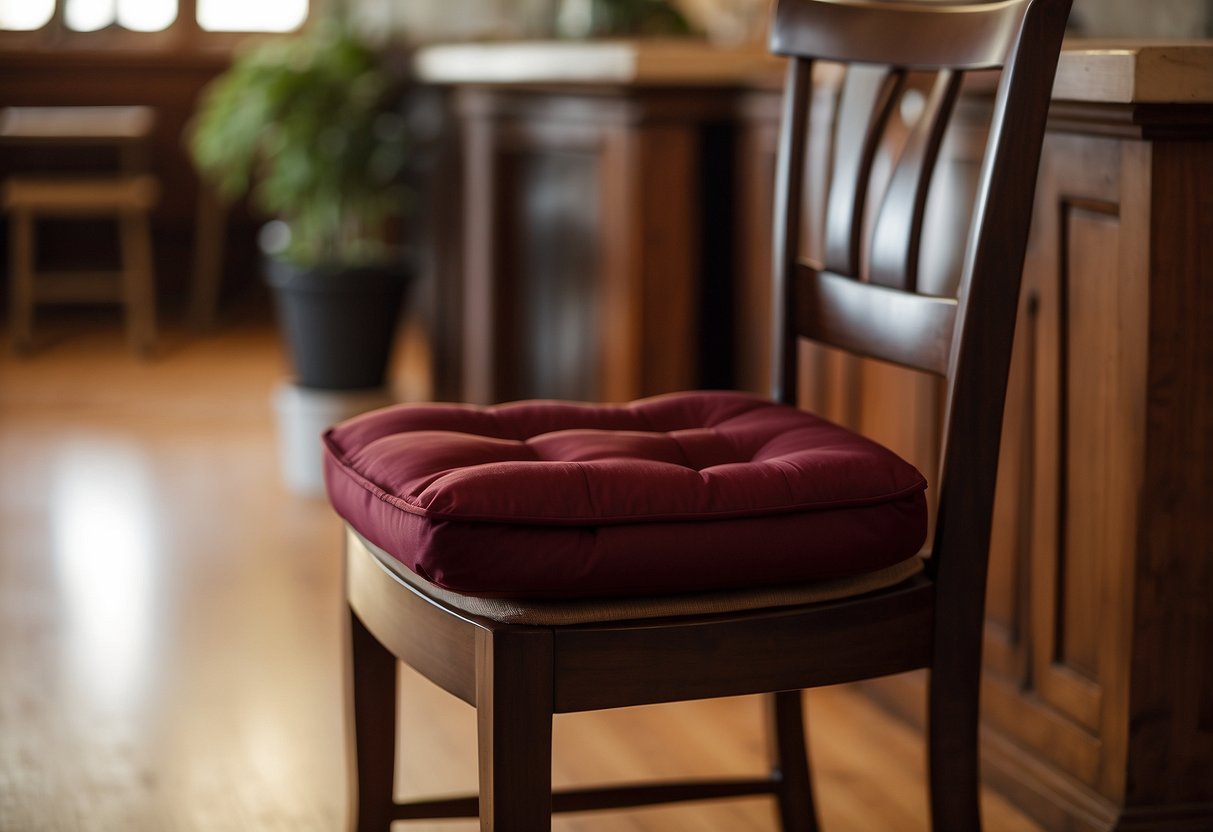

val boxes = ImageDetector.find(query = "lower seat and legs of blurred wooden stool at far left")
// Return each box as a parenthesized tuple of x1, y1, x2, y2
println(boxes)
(2, 175, 159, 353)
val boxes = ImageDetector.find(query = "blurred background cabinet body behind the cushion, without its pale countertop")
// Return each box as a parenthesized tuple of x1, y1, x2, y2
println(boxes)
(456, 86, 729, 401)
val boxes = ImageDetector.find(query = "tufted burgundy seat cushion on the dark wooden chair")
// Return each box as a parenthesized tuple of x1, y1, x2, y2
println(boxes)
(325, 393, 927, 598)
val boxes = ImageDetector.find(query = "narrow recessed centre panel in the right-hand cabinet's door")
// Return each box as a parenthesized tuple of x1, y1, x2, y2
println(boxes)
(1035, 203, 1121, 733)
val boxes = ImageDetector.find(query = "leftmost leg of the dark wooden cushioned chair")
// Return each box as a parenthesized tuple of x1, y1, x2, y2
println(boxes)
(346, 610, 397, 832)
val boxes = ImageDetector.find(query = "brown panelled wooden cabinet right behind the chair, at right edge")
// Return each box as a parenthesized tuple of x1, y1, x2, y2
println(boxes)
(739, 47, 1213, 832)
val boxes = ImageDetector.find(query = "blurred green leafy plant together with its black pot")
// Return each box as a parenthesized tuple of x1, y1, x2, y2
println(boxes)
(188, 19, 410, 389)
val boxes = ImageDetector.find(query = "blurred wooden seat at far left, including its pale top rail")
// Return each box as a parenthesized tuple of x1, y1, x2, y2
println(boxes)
(0, 107, 159, 353)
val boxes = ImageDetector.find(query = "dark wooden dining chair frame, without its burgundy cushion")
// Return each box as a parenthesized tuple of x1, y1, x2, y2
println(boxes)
(329, 0, 1070, 832)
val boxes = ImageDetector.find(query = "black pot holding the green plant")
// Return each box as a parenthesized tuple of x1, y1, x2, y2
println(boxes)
(266, 260, 411, 391)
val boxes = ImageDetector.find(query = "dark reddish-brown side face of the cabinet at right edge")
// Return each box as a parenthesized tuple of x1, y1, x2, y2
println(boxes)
(1126, 133, 1213, 820)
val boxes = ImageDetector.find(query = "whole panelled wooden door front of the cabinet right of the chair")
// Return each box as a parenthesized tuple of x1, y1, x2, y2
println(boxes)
(986, 135, 1147, 794)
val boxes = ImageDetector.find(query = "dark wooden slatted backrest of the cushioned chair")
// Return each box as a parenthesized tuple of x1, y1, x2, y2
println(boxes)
(770, 0, 1070, 587)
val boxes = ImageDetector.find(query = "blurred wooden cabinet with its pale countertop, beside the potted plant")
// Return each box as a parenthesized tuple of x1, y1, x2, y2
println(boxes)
(417, 41, 773, 403)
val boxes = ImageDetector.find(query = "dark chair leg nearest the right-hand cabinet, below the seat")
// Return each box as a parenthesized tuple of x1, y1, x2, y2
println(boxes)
(927, 660, 981, 832)
